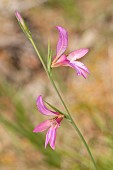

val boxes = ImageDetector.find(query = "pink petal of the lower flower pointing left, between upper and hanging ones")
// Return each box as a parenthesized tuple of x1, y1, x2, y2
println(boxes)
(33, 120, 51, 132)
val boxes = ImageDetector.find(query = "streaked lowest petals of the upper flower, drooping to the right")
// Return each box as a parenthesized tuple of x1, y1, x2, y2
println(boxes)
(70, 61, 89, 78)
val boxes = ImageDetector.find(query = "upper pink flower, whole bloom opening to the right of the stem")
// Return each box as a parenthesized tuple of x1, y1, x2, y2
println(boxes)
(51, 26, 89, 78)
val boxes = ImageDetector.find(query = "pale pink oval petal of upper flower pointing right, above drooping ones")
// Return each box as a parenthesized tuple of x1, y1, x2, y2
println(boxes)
(67, 48, 89, 61)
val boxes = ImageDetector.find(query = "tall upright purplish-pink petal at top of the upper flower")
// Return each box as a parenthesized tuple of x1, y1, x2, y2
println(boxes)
(56, 26, 68, 57)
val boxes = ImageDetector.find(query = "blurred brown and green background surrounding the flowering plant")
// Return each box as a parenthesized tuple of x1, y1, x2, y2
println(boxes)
(0, 0, 113, 170)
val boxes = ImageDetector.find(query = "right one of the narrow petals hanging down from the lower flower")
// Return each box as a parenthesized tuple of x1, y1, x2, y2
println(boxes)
(49, 125, 58, 149)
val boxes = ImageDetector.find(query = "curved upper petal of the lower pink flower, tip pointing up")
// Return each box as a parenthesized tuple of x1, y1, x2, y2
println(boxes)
(36, 95, 58, 116)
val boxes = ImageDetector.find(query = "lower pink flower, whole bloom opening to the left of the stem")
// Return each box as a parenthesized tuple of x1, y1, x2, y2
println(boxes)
(33, 96, 64, 149)
